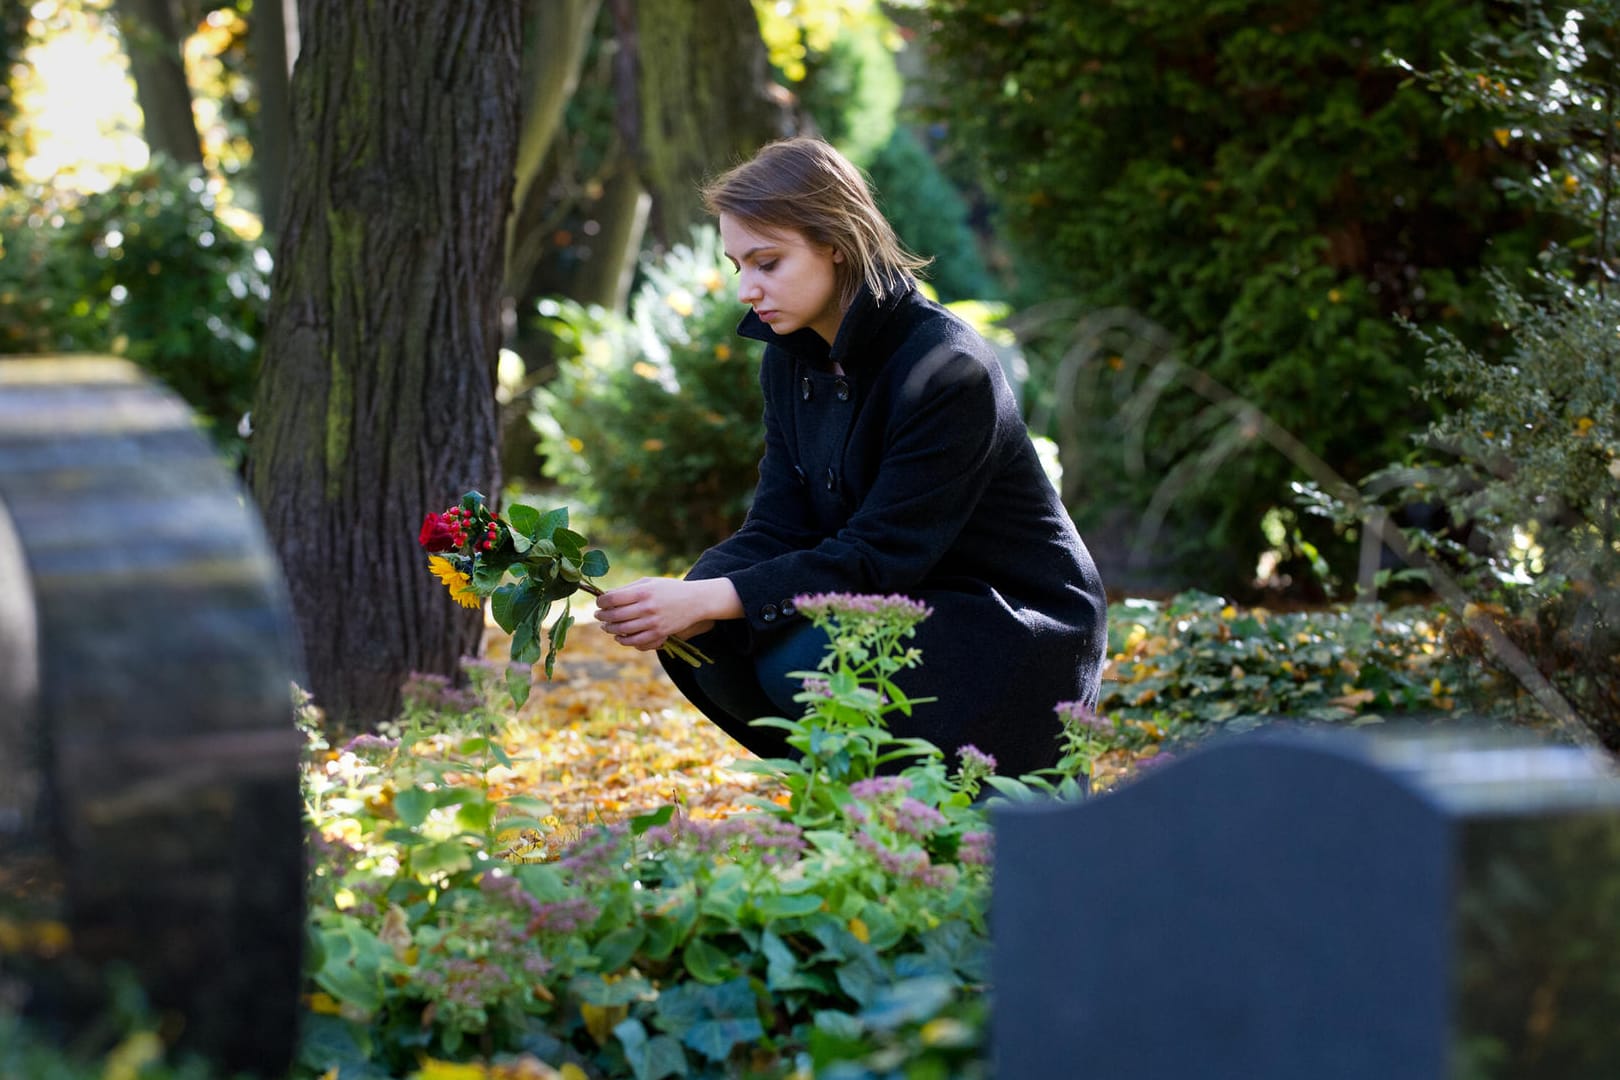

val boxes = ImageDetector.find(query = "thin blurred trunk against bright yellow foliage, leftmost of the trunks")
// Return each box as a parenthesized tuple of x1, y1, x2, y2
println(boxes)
(117, 0, 203, 165)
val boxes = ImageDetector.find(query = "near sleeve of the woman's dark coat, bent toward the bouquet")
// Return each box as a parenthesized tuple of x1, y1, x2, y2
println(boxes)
(726, 335, 1016, 633)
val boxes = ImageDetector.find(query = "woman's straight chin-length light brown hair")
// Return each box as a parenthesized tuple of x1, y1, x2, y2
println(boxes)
(703, 136, 930, 308)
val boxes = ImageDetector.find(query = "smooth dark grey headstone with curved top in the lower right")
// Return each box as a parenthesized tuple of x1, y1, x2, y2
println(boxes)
(991, 732, 1620, 1080)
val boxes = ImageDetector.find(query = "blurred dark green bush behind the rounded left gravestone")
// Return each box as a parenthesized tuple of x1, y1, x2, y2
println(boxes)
(0, 159, 269, 455)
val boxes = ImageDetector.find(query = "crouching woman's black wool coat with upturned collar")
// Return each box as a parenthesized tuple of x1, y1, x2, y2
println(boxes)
(661, 283, 1106, 776)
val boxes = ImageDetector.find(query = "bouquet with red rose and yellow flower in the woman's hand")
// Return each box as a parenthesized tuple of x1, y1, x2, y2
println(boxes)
(416, 491, 708, 706)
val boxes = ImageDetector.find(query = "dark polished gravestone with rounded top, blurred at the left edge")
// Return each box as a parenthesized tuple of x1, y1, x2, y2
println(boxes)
(0, 358, 305, 1077)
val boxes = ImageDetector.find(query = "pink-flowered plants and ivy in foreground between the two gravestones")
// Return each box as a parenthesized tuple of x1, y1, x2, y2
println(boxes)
(298, 597, 1056, 1080)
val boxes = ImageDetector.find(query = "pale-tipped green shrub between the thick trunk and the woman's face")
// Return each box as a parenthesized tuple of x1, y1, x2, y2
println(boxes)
(531, 227, 765, 563)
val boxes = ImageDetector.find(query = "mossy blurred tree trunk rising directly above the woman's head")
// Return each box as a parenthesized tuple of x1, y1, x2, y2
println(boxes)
(614, 0, 791, 243)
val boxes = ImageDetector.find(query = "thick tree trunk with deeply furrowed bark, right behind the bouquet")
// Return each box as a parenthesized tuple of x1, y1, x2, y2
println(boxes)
(249, 0, 522, 729)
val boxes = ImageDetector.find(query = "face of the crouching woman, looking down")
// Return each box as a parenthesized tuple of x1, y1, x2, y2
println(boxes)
(719, 214, 844, 345)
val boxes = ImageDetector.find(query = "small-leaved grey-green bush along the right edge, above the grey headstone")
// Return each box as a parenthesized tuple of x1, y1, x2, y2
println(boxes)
(1317, 2, 1620, 750)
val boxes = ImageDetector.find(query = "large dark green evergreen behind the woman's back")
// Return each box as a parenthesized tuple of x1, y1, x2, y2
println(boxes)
(928, 0, 1541, 591)
